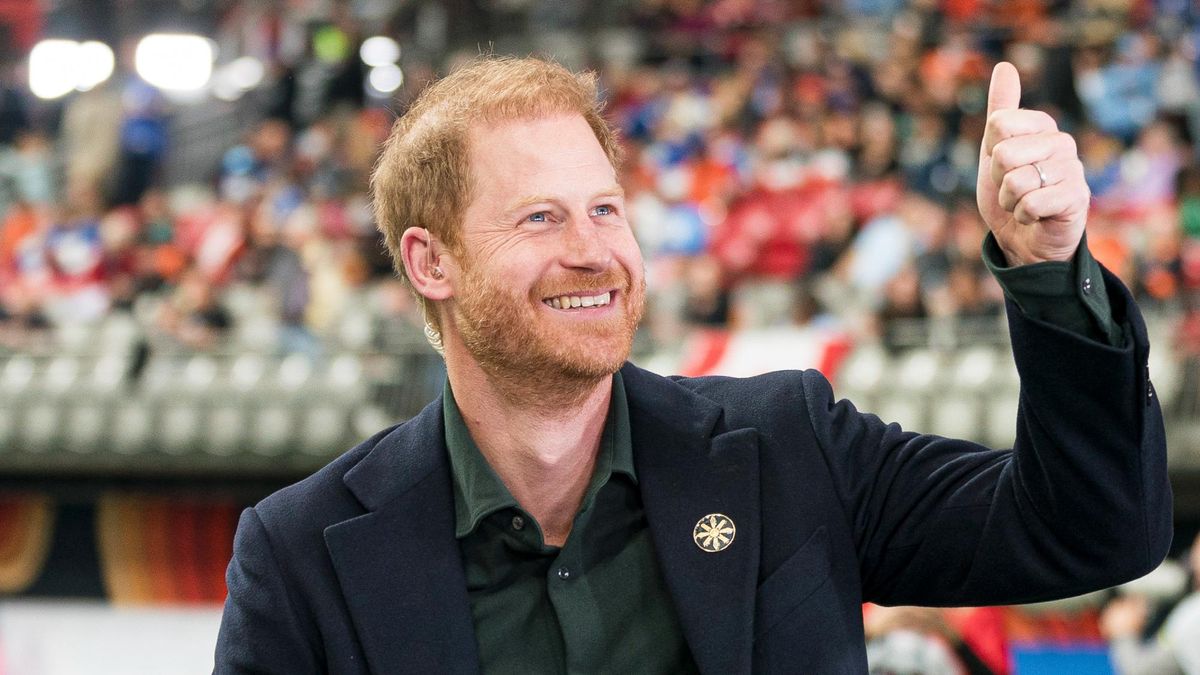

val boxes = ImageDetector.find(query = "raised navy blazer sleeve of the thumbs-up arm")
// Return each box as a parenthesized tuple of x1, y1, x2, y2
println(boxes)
(804, 265, 1171, 605)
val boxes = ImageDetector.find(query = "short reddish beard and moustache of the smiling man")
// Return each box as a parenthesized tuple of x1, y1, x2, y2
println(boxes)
(452, 254, 646, 398)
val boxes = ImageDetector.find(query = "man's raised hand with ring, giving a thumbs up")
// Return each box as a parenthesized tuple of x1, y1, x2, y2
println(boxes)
(976, 61, 1091, 265)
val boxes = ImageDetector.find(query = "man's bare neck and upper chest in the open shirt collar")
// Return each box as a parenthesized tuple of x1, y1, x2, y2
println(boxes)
(445, 345, 612, 545)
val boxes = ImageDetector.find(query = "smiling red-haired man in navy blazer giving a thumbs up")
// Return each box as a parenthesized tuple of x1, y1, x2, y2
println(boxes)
(216, 59, 1171, 674)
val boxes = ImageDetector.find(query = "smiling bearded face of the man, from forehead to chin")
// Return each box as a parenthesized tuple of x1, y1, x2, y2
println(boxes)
(449, 115, 644, 381)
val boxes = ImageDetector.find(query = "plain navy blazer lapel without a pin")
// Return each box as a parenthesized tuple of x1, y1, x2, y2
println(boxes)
(325, 398, 479, 674)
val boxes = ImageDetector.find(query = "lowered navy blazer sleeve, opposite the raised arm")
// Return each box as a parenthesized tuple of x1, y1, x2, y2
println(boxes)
(214, 508, 323, 675)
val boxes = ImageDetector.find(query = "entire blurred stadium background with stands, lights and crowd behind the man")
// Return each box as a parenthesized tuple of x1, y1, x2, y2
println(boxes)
(0, 0, 1200, 674)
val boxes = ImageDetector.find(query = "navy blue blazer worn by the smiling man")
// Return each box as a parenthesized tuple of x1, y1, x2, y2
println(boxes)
(216, 269, 1171, 675)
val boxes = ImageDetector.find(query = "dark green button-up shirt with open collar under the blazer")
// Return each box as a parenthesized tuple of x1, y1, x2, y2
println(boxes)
(443, 372, 696, 675)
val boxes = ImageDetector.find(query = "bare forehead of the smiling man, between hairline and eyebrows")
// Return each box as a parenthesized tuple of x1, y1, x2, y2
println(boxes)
(468, 114, 616, 197)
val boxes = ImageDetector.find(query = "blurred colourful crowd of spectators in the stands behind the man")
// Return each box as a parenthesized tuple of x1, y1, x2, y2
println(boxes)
(0, 0, 1200, 673)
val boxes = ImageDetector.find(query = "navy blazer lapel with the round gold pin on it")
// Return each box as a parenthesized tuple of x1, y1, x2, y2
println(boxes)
(622, 365, 760, 674)
